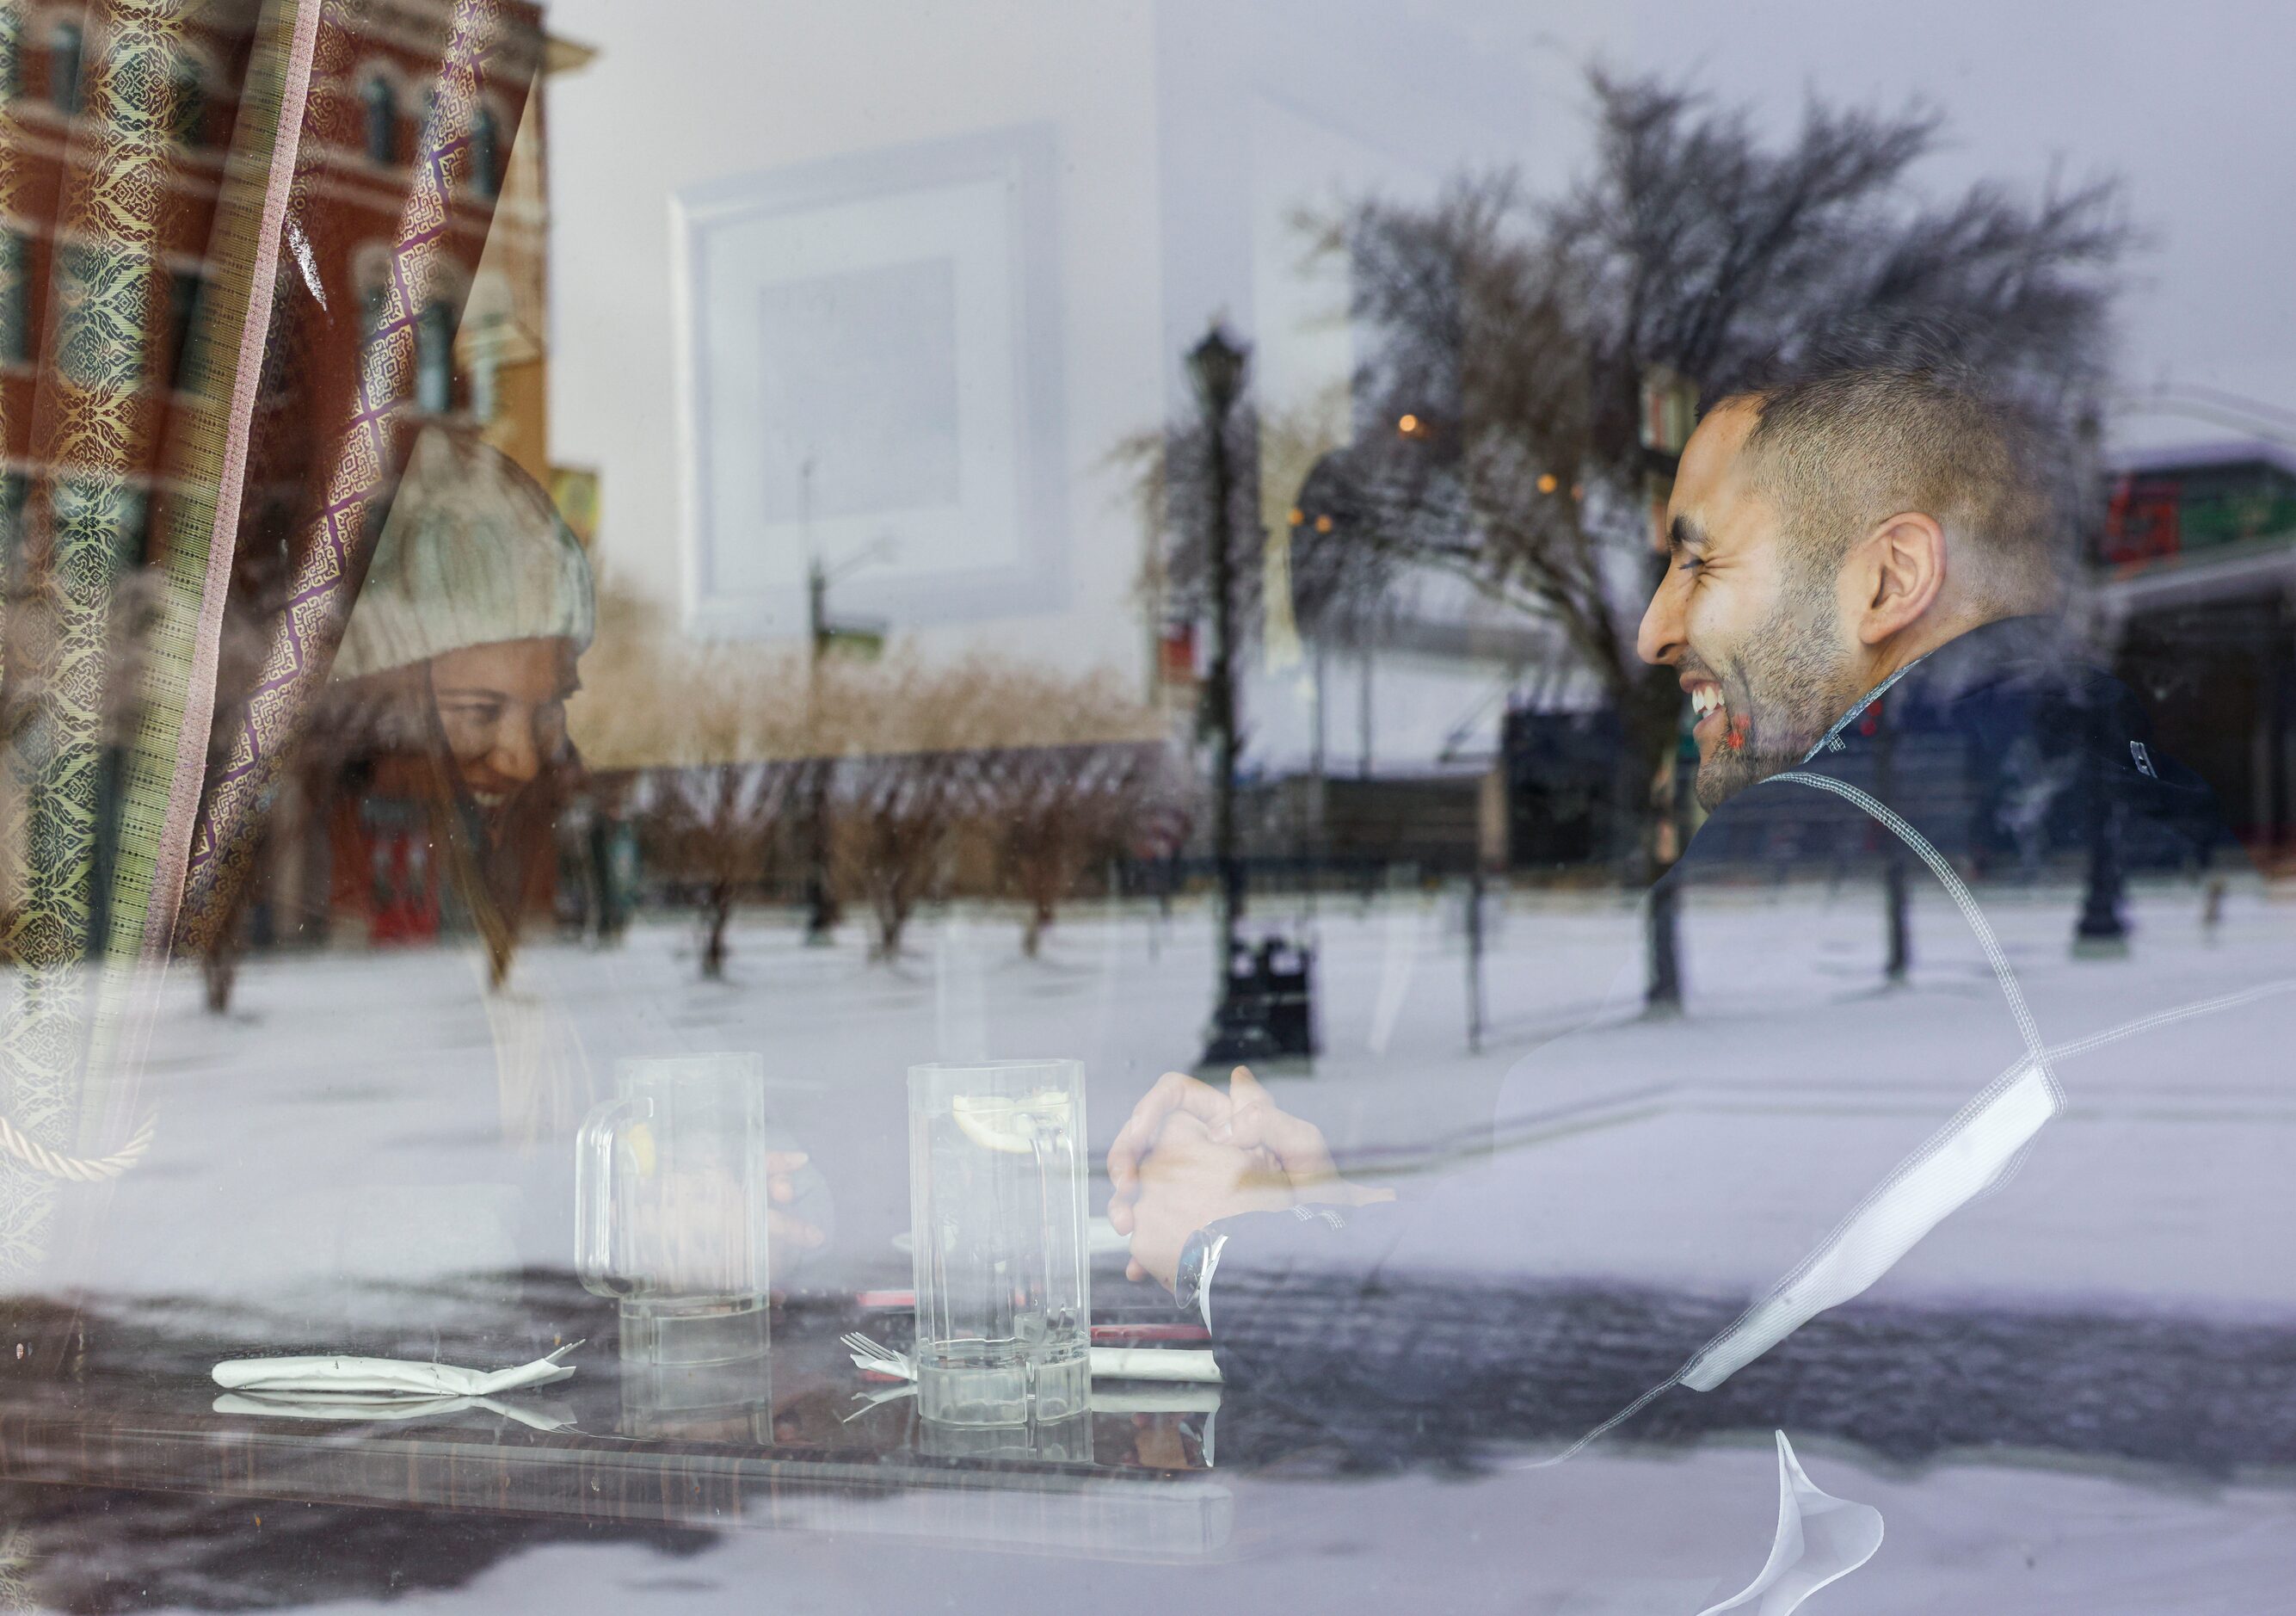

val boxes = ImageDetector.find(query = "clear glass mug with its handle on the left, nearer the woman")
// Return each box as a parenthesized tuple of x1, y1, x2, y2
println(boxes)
(574, 1053, 769, 1377)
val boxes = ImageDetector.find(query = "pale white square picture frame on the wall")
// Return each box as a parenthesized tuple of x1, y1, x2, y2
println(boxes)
(675, 126, 1068, 636)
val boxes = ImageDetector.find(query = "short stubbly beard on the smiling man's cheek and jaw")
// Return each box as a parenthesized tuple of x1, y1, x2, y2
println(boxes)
(1692, 581, 1857, 812)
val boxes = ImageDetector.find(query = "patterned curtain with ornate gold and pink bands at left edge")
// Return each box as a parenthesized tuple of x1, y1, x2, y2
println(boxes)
(0, 0, 542, 1281)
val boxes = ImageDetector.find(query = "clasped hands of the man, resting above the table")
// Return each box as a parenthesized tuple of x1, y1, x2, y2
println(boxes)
(1109, 1067, 1394, 1290)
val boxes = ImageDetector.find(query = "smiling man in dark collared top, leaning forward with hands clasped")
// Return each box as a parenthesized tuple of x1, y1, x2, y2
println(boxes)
(1109, 369, 2259, 1477)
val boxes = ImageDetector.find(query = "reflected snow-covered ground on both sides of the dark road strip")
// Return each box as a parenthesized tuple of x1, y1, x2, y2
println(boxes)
(40, 886, 2296, 1616)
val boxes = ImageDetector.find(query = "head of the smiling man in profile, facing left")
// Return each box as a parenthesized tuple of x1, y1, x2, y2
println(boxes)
(1634, 369, 2055, 811)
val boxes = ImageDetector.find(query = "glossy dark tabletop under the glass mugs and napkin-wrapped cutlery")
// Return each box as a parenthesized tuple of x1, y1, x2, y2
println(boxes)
(0, 1306, 1233, 1558)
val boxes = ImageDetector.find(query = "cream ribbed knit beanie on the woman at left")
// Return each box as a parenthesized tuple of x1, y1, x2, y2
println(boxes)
(333, 427, 597, 680)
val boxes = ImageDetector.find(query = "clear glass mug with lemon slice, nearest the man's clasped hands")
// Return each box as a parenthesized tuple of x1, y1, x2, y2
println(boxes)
(909, 1060, 1093, 1426)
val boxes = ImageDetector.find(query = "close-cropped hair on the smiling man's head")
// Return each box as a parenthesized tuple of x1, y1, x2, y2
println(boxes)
(1724, 365, 2057, 613)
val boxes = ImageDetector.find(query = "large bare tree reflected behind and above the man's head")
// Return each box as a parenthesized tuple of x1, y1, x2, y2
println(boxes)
(1300, 71, 2131, 1008)
